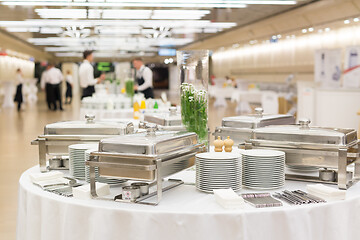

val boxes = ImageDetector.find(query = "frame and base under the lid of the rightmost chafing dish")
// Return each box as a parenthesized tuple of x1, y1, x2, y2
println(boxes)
(245, 139, 360, 189)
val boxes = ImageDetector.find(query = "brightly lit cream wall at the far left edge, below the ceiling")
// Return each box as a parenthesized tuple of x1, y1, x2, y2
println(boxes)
(0, 56, 35, 82)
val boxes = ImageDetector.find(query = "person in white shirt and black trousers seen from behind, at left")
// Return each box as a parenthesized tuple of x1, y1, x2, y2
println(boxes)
(41, 63, 64, 111)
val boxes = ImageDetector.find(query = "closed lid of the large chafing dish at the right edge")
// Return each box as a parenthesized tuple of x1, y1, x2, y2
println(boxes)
(253, 120, 357, 146)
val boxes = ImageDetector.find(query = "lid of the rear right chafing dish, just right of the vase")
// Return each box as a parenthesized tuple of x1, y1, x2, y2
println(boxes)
(222, 108, 295, 129)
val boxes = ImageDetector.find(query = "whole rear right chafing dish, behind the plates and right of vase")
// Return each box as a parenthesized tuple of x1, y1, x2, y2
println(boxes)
(214, 108, 295, 144)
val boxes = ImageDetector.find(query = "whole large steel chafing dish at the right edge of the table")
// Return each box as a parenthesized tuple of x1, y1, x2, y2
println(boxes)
(245, 119, 360, 189)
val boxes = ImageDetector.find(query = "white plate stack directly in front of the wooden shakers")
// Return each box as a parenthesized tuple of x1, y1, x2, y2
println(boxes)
(195, 152, 241, 193)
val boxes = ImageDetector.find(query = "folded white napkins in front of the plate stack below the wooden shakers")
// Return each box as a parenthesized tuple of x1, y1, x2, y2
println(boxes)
(213, 188, 245, 208)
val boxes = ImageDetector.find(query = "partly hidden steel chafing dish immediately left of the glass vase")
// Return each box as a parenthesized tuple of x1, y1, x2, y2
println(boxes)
(144, 107, 186, 131)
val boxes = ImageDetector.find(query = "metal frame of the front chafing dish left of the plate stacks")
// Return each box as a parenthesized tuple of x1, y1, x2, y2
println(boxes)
(85, 143, 206, 206)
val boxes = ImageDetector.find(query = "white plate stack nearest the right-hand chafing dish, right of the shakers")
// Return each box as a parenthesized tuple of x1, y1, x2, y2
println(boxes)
(241, 149, 285, 189)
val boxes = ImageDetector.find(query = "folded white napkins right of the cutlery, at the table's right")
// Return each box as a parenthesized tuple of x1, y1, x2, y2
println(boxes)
(306, 183, 346, 201)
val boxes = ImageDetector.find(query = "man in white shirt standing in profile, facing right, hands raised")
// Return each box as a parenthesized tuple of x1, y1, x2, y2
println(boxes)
(79, 51, 105, 99)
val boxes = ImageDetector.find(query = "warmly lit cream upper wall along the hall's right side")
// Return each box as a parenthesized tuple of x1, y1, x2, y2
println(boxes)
(212, 25, 360, 82)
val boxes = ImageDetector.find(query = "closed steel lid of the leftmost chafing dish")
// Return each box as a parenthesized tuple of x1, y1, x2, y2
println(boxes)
(44, 115, 134, 135)
